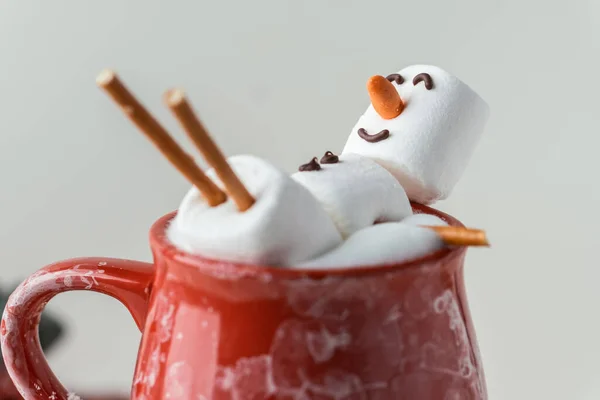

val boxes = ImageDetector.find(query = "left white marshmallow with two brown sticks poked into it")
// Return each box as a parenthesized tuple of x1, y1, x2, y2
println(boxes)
(167, 156, 342, 266)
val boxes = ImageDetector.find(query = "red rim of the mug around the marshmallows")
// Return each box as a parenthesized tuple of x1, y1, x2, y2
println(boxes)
(150, 202, 467, 280)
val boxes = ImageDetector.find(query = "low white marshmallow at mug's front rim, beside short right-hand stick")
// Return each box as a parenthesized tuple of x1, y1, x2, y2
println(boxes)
(297, 214, 446, 269)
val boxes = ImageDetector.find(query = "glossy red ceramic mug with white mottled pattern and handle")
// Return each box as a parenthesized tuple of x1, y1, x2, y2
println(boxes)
(1, 204, 487, 400)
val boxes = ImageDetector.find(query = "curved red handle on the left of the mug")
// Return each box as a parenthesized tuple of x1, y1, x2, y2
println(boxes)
(0, 258, 154, 400)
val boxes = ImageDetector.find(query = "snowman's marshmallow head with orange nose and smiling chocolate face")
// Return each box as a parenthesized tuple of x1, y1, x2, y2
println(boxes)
(343, 65, 489, 204)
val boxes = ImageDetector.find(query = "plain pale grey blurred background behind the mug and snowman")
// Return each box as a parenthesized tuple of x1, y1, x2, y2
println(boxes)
(0, 0, 600, 400)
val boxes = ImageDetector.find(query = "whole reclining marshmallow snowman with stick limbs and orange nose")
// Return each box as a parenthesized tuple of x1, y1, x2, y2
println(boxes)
(97, 66, 488, 268)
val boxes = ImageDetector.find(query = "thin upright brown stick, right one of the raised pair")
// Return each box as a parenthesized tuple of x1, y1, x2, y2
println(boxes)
(165, 90, 255, 212)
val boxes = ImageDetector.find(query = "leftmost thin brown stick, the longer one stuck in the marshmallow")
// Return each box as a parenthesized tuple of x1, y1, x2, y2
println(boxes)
(96, 70, 227, 207)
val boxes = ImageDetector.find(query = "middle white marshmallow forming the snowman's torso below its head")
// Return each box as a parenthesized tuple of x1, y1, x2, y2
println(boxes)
(292, 154, 412, 237)
